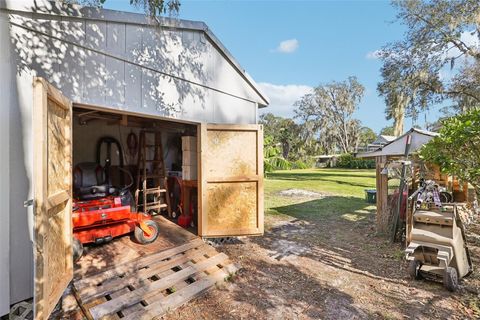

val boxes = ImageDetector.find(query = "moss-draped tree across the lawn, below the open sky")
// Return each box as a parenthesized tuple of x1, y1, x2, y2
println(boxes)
(295, 77, 365, 153)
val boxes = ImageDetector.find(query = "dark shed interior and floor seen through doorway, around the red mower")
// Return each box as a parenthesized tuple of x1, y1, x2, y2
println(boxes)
(72, 105, 198, 278)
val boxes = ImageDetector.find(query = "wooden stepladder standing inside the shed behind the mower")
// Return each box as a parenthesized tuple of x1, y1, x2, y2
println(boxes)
(135, 130, 171, 216)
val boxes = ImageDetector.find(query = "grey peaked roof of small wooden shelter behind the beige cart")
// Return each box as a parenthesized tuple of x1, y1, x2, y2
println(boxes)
(357, 128, 438, 158)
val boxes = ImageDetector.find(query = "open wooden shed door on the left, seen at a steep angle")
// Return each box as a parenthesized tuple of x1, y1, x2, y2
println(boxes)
(33, 78, 73, 319)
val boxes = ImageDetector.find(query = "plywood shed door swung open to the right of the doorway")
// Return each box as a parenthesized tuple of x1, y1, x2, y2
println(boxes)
(198, 124, 263, 237)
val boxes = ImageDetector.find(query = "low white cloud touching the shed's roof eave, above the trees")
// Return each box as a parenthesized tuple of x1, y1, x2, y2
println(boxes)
(258, 82, 313, 118)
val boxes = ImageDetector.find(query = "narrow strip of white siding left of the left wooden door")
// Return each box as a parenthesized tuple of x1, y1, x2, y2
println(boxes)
(0, 7, 33, 315)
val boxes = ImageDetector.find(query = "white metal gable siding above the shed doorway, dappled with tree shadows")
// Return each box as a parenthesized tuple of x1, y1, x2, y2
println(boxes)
(4, 2, 259, 123)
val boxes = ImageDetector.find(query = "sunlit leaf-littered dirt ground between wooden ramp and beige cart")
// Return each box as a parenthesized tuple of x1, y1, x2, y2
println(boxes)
(164, 204, 480, 320)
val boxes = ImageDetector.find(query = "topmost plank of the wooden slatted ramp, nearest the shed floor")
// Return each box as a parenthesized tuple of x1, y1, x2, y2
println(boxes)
(75, 238, 204, 290)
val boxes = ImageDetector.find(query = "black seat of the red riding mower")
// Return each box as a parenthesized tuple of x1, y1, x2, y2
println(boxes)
(73, 162, 117, 201)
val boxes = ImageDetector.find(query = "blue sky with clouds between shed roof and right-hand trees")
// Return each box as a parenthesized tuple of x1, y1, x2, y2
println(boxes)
(105, 0, 437, 131)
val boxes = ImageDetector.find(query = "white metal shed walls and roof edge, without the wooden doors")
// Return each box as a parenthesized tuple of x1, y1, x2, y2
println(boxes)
(0, 0, 269, 315)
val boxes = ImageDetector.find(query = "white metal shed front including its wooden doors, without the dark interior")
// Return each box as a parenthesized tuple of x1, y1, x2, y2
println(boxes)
(0, 0, 268, 315)
